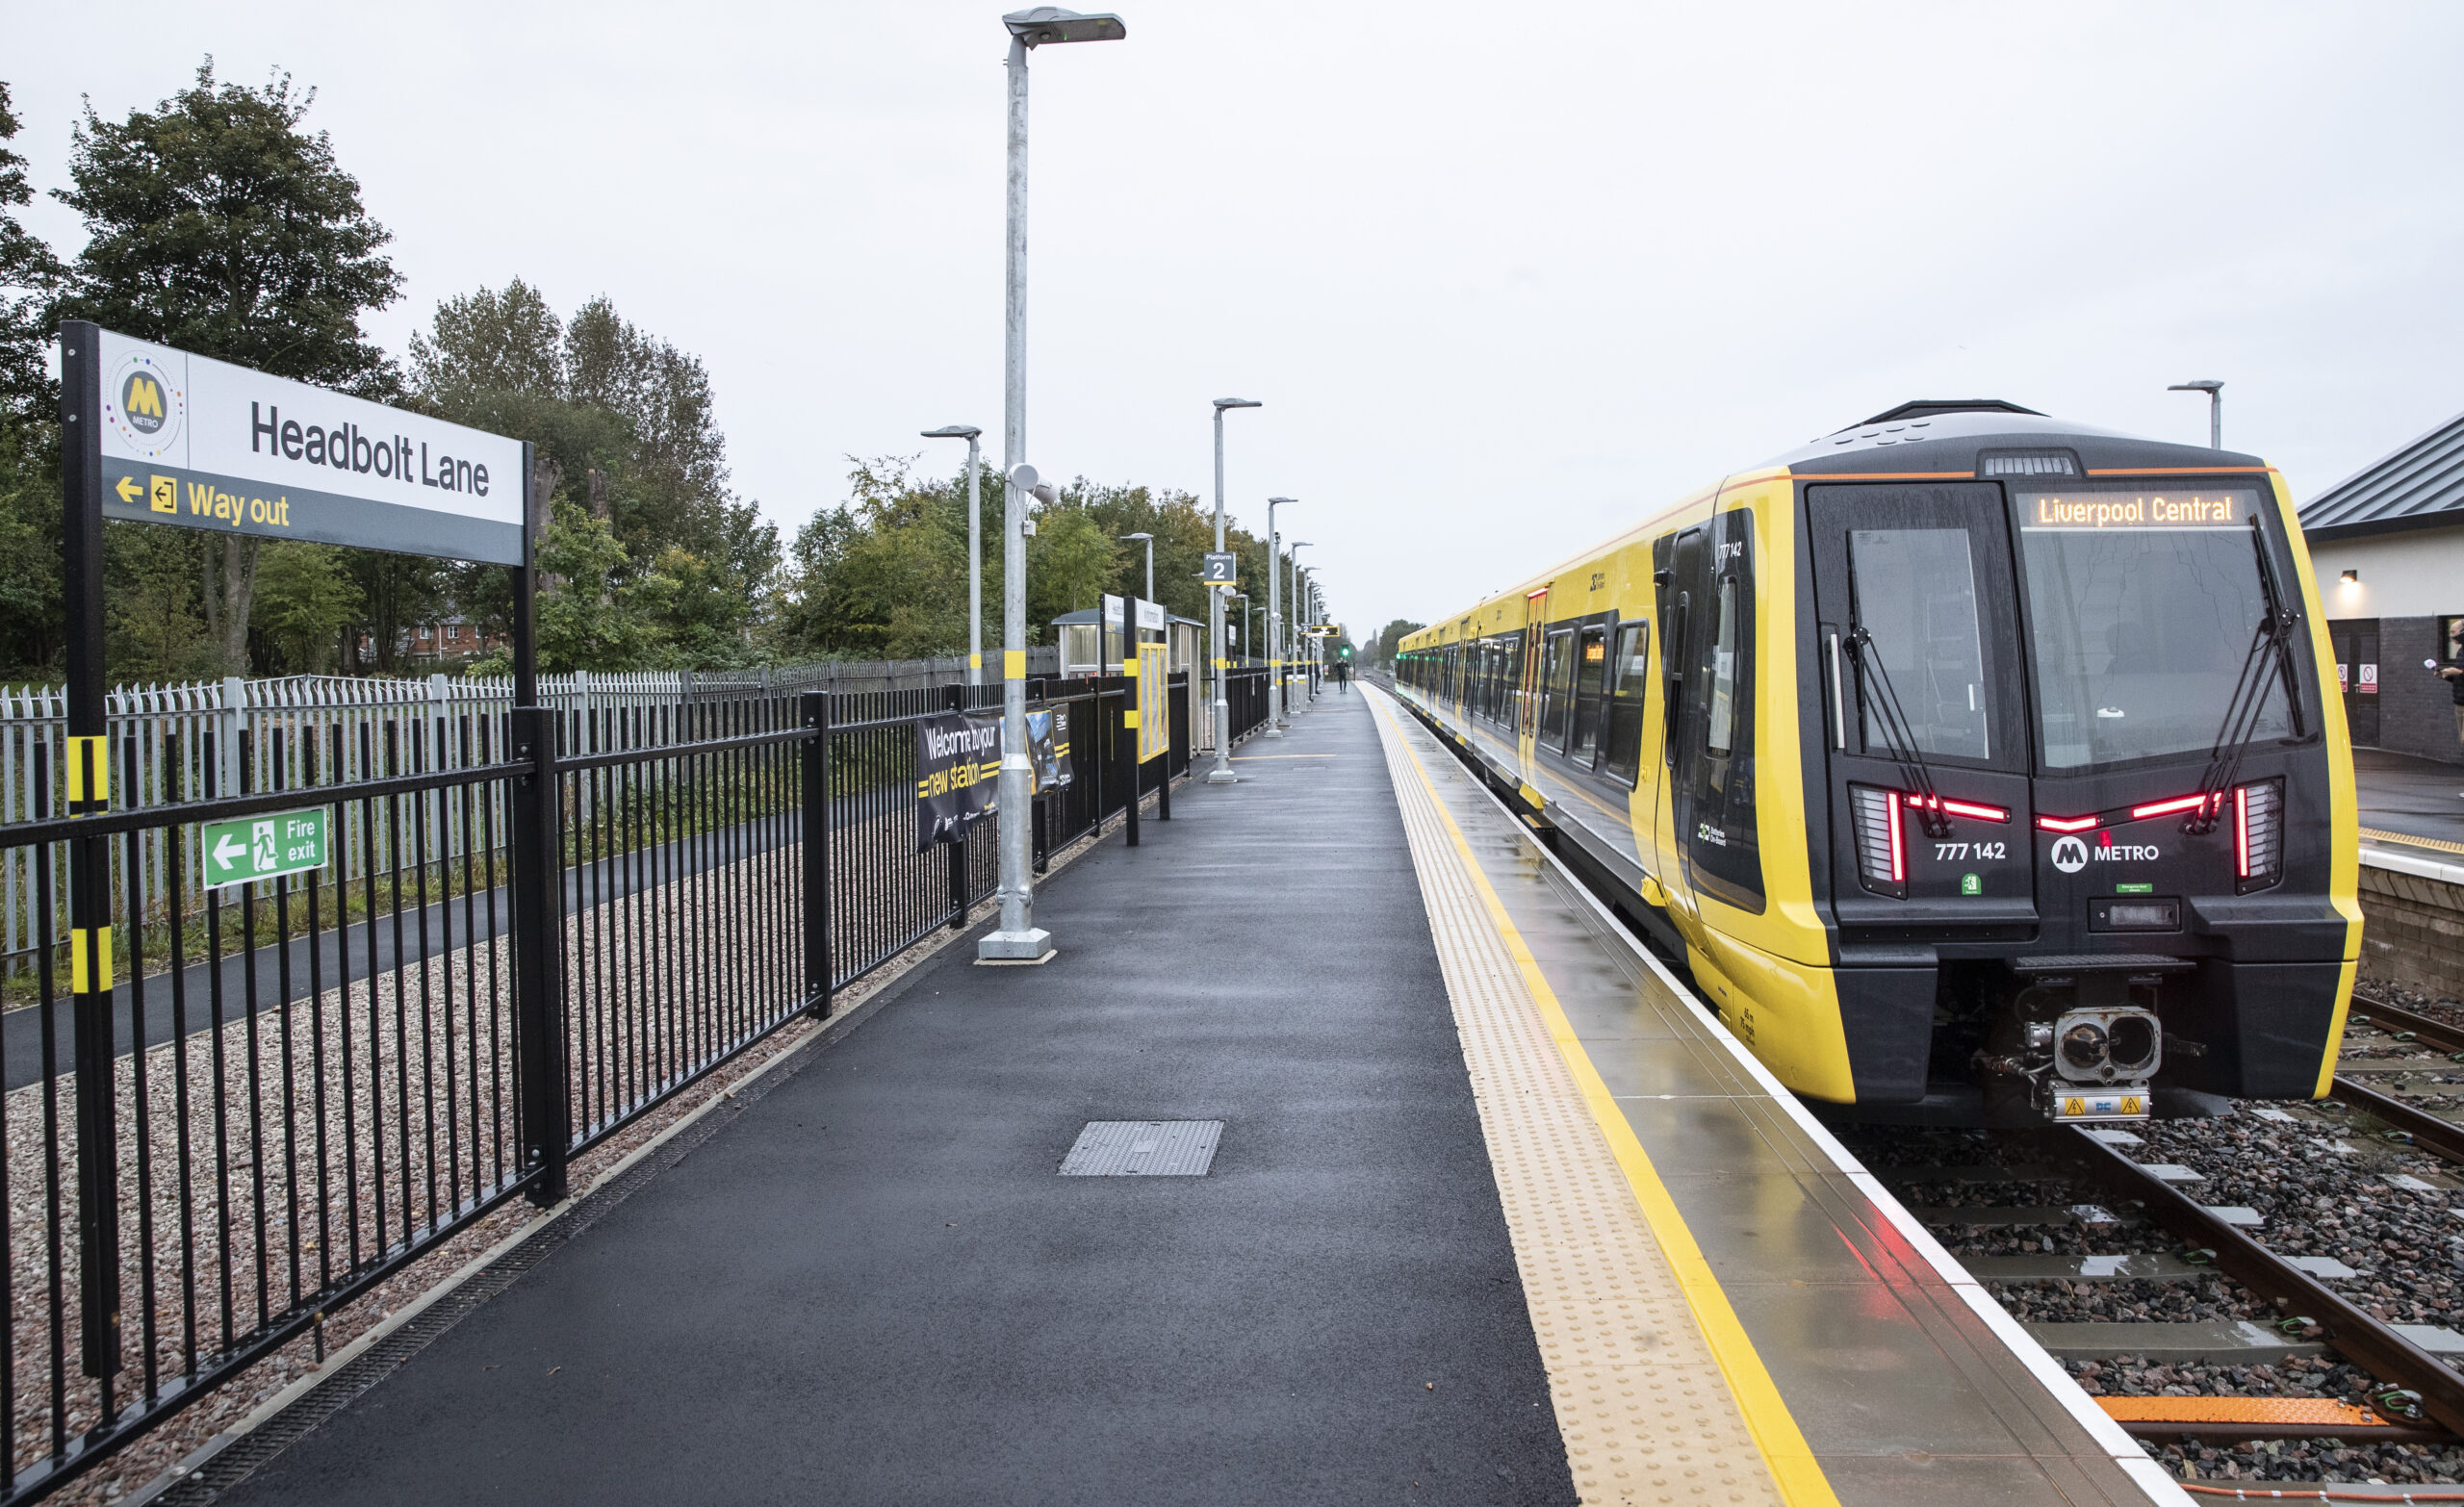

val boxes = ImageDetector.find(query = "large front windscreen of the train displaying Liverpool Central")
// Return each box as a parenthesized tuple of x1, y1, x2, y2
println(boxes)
(2014, 485, 2292, 773)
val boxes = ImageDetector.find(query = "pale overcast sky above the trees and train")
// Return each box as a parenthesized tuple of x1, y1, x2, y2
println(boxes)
(0, 0, 2464, 633)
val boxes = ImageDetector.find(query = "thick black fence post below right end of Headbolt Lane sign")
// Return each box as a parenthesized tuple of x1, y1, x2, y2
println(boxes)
(512, 706, 572, 1207)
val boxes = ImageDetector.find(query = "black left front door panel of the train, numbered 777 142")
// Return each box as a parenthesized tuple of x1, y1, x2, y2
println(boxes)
(1806, 483, 2036, 929)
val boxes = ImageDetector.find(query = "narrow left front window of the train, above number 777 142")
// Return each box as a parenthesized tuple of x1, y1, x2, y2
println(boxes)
(1848, 529, 2001, 761)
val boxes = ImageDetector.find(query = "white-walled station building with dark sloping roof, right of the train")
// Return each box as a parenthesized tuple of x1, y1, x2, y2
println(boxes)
(2301, 414, 2464, 763)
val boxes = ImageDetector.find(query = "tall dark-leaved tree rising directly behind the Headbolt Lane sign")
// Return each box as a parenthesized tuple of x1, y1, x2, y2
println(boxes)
(54, 57, 401, 670)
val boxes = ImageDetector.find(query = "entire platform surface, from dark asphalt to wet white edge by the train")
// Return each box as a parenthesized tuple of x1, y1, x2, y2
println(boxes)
(207, 689, 2186, 1507)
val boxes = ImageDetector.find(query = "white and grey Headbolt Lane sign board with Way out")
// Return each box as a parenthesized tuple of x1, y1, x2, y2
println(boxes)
(89, 330, 523, 564)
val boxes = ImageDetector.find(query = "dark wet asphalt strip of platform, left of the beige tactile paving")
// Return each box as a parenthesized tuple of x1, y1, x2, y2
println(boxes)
(219, 695, 1575, 1507)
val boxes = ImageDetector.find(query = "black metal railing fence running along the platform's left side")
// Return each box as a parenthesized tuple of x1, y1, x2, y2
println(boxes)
(0, 670, 1267, 1507)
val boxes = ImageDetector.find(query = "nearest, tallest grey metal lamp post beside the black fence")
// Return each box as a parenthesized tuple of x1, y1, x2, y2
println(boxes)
(976, 5, 1128, 963)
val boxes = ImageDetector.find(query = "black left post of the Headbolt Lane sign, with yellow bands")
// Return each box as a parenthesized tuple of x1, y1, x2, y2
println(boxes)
(44, 320, 120, 1418)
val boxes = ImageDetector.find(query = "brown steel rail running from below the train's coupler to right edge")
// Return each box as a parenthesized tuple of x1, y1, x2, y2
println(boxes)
(2042, 1128, 2464, 1438)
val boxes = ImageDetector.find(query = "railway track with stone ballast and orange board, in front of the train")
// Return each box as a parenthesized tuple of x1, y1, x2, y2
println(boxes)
(1856, 997, 2464, 1502)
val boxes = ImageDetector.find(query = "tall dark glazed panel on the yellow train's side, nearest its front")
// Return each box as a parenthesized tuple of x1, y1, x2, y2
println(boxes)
(1660, 507, 1764, 911)
